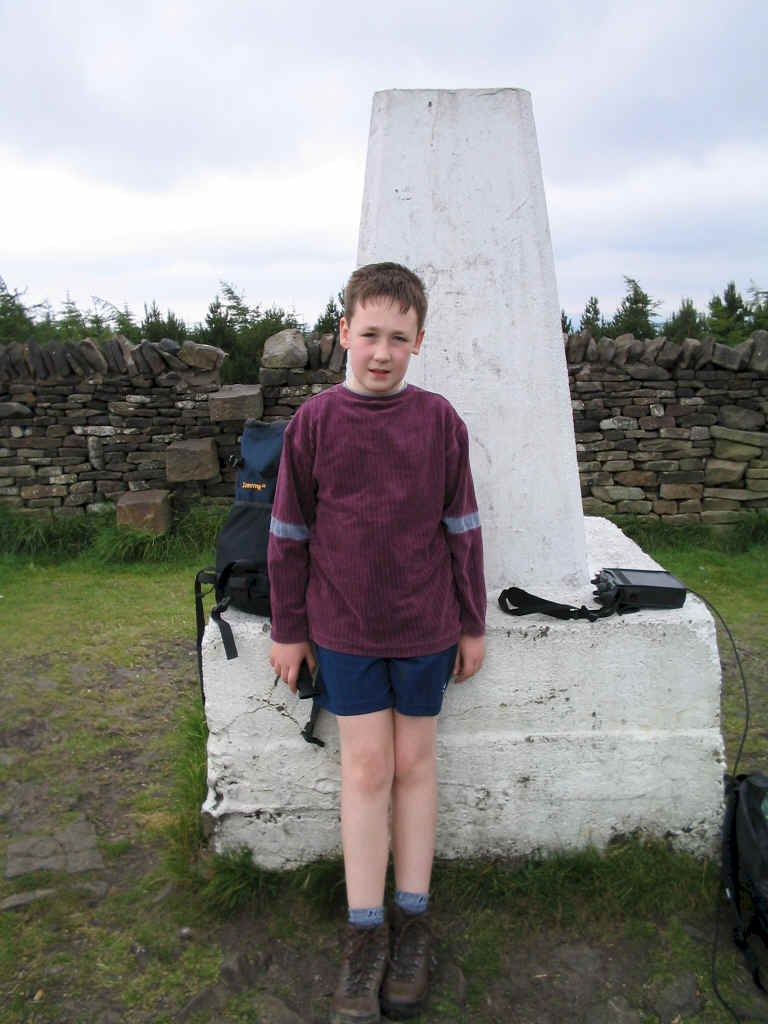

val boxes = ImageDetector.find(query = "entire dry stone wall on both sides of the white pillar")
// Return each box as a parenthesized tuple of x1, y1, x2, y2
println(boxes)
(0, 321, 768, 525)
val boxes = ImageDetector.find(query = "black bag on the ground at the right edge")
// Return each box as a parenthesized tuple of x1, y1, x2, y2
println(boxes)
(723, 774, 768, 991)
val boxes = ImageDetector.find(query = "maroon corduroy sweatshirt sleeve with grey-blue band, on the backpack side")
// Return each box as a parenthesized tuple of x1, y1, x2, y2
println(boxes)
(267, 414, 314, 643)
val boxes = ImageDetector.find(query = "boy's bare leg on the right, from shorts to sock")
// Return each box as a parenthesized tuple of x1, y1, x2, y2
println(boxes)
(392, 712, 437, 893)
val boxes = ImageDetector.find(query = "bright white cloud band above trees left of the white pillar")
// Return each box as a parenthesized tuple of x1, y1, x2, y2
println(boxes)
(0, 142, 362, 322)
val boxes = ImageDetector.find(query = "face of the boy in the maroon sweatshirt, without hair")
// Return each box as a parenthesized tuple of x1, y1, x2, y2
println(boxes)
(339, 297, 424, 394)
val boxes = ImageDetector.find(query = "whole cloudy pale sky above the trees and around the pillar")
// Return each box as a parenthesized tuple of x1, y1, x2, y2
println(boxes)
(0, 0, 768, 326)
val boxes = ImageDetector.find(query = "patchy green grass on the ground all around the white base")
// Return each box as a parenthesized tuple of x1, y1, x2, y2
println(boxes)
(0, 517, 768, 1024)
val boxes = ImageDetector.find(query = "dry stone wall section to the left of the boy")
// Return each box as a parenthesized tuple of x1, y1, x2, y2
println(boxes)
(0, 331, 343, 521)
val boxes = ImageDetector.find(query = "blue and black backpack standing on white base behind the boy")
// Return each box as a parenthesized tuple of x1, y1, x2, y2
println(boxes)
(195, 420, 288, 701)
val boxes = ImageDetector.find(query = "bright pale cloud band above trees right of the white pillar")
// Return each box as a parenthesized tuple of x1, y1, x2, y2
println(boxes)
(547, 143, 768, 317)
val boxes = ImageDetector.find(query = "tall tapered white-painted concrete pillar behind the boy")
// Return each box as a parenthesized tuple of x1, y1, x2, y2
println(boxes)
(357, 89, 587, 600)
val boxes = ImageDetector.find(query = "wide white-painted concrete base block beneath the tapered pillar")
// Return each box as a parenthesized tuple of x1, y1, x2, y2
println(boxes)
(203, 519, 725, 868)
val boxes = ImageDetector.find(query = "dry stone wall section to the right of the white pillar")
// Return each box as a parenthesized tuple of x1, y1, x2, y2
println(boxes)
(566, 331, 768, 525)
